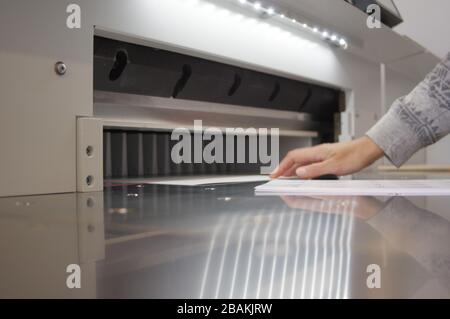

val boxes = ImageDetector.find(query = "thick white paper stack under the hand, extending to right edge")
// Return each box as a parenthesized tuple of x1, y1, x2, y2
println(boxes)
(255, 179, 450, 196)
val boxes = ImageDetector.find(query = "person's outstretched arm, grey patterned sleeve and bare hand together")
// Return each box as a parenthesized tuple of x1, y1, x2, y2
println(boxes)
(271, 53, 450, 179)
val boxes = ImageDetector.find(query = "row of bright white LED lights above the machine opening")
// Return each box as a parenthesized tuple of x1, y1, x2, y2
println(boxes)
(237, 0, 348, 49)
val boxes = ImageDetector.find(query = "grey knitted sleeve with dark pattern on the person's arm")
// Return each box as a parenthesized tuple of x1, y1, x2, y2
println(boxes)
(366, 53, 450, 167)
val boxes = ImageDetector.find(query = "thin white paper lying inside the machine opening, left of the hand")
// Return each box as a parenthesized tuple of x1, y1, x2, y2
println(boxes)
(105, 175, 270, 186)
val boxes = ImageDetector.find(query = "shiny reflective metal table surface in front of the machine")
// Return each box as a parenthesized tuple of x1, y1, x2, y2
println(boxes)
(0, 176, 450, 298)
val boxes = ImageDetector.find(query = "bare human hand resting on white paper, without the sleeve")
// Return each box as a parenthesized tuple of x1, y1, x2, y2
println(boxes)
(271, 136, 384, 179)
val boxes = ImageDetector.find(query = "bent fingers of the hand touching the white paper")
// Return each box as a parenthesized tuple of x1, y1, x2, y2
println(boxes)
(270, 146, 323, 178)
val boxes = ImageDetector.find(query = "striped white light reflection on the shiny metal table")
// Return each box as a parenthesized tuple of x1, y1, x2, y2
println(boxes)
(200, 200, 355, 298)
